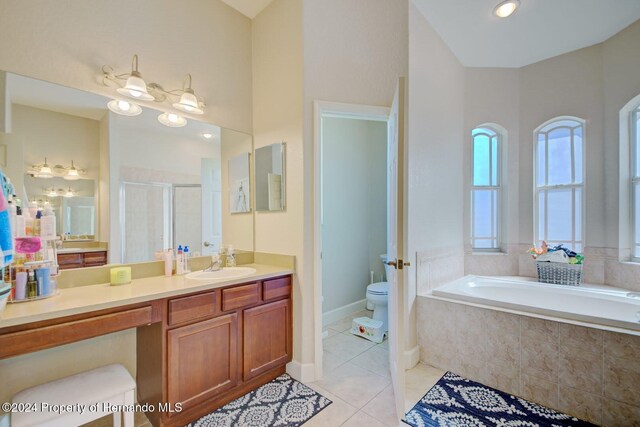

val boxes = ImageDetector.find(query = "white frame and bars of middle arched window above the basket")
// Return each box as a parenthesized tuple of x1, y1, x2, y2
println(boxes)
(533, 116, 587, 252)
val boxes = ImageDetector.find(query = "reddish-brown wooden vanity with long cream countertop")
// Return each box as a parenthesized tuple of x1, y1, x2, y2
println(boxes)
(0, 264, 293, 426)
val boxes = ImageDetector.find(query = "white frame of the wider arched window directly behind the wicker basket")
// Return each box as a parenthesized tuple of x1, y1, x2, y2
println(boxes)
(533, 116, 587, 252)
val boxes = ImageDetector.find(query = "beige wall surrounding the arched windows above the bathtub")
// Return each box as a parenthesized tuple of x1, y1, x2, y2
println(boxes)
(463, 21, 640, 289)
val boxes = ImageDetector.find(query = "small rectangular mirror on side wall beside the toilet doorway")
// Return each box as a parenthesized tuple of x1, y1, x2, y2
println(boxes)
(255, 142, 285, 212)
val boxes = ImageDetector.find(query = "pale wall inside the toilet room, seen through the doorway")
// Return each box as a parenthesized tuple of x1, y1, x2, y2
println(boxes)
(322, 118, 387, 313)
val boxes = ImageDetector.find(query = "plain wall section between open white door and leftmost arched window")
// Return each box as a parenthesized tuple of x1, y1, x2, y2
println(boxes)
(405, 4, 464, 348)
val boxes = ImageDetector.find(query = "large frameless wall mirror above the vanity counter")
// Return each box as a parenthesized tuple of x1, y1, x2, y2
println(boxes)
(0, 72, 254, 263)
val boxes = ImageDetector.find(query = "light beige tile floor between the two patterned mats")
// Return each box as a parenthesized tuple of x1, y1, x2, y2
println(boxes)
(305, 311, 444, 427)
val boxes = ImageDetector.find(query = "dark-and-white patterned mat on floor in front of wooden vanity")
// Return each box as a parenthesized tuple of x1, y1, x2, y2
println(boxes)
(187, 374, 332, 427)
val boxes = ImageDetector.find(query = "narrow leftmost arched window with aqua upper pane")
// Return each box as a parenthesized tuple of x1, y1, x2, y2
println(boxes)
(471, 126, 502, 249)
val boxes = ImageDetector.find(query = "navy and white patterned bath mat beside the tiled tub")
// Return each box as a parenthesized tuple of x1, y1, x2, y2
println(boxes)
(403, 372, 594, 427)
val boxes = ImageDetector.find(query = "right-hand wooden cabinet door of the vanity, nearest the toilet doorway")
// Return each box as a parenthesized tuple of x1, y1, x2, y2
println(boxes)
(243, 299, 292, 380)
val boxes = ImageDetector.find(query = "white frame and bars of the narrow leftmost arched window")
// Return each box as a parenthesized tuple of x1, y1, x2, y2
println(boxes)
(469, 124, 503, 252)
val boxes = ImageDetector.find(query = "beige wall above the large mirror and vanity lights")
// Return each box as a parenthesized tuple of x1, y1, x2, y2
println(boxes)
(0, 0, 252, 132)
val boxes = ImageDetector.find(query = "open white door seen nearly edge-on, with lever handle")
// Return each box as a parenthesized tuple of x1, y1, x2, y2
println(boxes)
(387, 77, 406, 419)
